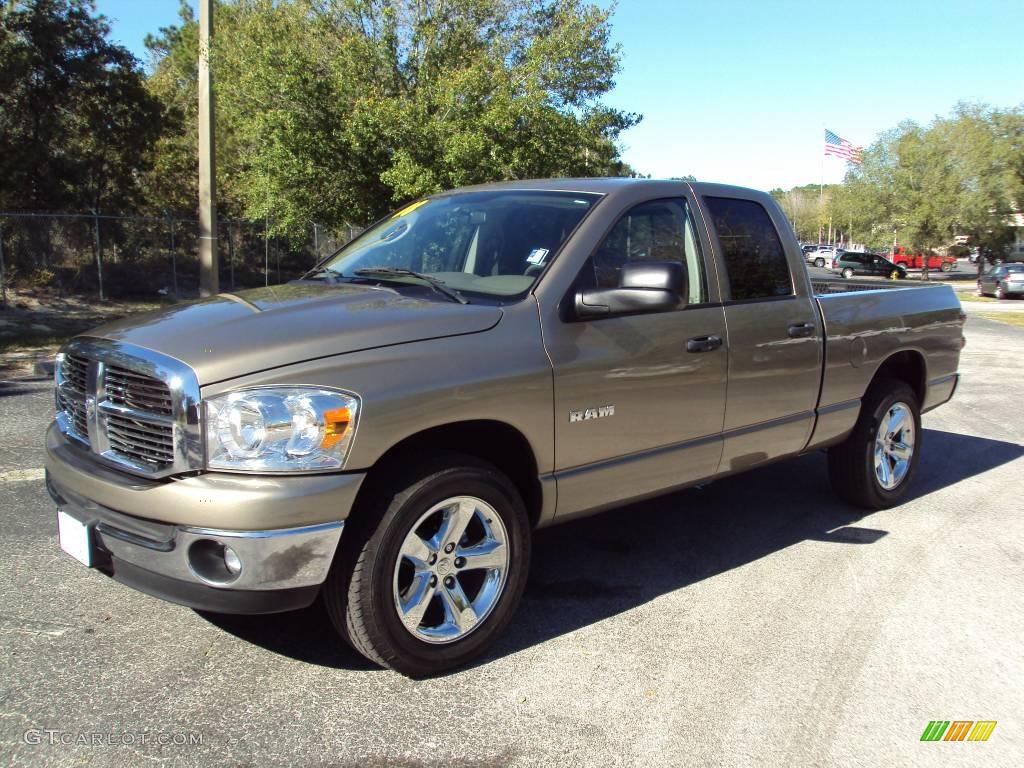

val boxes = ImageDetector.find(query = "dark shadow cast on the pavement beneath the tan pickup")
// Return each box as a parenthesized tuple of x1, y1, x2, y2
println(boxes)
(195, 429, 1024, 670)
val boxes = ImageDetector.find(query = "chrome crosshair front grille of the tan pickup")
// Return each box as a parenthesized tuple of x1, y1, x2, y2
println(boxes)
(56, 339, 203, 477)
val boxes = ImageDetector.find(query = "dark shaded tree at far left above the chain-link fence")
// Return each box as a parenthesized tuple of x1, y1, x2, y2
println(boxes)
(0, 0, 160, 211)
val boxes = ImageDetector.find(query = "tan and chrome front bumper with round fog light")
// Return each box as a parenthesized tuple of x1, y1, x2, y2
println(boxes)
(46, 428, 362, 613)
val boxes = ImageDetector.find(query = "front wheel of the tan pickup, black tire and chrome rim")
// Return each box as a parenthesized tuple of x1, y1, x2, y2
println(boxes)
(324, 454, 530, 677)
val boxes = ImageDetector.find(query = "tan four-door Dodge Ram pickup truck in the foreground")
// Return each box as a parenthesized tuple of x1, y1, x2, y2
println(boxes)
(46, 179, 965, 676)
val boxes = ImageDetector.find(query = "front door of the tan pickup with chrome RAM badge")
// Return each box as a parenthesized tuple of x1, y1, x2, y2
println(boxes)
(546, 198, 726, 516)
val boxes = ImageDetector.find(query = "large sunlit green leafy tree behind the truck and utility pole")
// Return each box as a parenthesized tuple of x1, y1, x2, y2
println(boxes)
(147, 0, 640, 240)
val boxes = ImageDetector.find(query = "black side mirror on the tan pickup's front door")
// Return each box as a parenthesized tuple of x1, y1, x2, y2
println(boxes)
(575, 261, 688, 317)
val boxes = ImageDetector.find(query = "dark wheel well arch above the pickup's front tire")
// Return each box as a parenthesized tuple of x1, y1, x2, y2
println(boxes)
(355, 419, 542, 527)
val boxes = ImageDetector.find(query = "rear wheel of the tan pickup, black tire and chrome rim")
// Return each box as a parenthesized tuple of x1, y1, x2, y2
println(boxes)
(828, 379, 922, 509)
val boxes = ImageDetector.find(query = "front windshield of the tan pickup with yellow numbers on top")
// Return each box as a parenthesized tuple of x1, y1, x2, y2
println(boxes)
(323, 189, 600, 300)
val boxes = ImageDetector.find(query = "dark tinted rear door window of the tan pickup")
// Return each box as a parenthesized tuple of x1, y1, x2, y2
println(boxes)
(705, 198, 793, 301)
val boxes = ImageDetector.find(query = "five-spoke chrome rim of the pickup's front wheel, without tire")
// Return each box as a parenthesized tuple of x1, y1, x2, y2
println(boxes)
(392, 496, 509, 644)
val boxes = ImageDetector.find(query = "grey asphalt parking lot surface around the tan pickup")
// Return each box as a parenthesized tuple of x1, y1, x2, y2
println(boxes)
(0, 317, 1024, 766)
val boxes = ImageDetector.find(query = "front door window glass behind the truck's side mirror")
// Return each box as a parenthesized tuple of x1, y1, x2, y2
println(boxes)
(585, 199, 708, 304)
